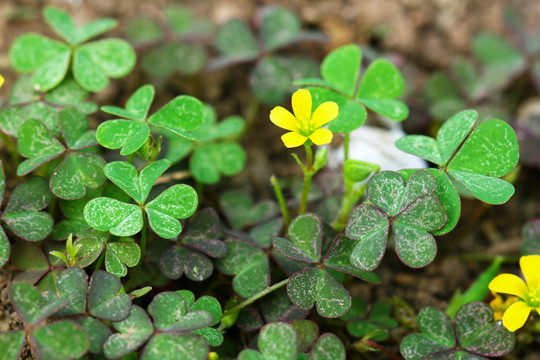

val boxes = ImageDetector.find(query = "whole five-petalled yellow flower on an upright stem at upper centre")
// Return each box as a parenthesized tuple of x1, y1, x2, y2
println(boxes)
(270, 89, 339, 148)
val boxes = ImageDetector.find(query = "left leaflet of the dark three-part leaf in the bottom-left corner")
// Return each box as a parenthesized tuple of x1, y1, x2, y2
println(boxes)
(9, 282, 68, 325)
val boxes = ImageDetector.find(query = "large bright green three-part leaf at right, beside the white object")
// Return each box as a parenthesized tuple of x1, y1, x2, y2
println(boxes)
(396, 110, 519, 204)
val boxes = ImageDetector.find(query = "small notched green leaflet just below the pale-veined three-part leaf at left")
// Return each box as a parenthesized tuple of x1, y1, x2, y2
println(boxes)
(105, 241, 141, 277)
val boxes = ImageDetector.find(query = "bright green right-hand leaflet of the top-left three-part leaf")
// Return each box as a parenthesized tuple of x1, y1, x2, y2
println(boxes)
(73, 39, 135, 92)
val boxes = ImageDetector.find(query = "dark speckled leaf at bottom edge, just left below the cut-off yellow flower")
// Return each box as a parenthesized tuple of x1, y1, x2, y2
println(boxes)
(400, 302, 515, 360)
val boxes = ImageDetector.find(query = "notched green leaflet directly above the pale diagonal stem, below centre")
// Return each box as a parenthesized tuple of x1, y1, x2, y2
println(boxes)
(215, 240, 270, 298)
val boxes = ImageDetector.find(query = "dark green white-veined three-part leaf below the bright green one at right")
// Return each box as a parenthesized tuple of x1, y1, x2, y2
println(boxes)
(346, 171, 447, 271)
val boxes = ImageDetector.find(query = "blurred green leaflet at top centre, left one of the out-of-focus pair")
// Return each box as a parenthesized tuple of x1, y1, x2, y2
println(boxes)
(215, 19, 259, 58)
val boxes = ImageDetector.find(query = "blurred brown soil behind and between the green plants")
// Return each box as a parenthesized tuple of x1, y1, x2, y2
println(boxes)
(0, 0, 540, 360)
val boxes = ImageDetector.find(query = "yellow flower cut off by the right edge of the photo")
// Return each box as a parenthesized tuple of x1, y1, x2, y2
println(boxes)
(489, 255, 540, 331)
